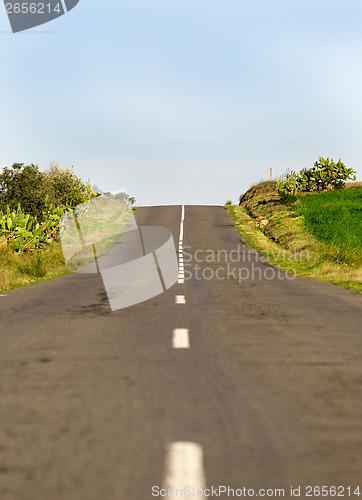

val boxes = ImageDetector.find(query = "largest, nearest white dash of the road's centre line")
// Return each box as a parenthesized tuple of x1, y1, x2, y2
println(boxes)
(163, 441, 206, 498)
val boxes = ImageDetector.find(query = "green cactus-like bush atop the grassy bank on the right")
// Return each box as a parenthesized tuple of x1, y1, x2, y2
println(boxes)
(277, 157, 356, 195)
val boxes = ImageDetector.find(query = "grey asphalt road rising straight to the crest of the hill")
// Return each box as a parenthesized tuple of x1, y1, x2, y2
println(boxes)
(0, 206, 362, 500)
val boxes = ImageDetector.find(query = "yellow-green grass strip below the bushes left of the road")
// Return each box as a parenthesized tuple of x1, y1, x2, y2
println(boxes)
(0, 239, 70, 291)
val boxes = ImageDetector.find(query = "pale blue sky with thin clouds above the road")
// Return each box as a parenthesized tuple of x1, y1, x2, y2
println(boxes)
(0, 0, 362, 205)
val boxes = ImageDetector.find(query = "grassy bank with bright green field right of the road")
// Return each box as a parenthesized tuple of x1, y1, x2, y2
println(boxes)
(228, 181, 362, 293)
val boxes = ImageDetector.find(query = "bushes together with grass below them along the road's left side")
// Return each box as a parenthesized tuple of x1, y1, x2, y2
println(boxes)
(0, 163, 135, 291)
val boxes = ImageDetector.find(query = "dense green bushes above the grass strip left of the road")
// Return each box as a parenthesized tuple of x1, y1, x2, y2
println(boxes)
(0, 163, 135, 258)
